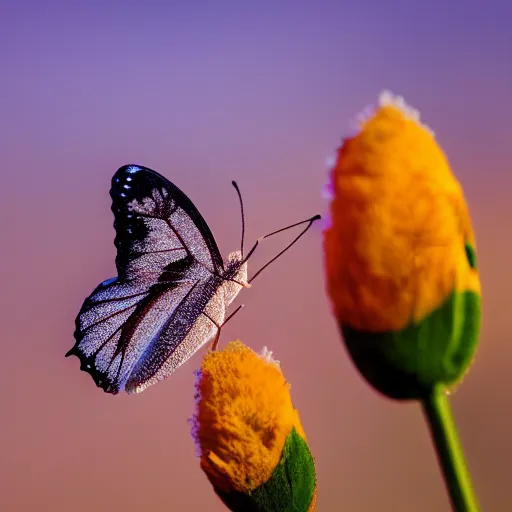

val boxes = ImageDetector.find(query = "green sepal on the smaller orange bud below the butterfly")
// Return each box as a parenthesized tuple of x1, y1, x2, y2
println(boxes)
(214, 428, 316, 512)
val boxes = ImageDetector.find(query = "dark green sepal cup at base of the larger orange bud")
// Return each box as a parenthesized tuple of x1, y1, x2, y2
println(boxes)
(340, 291, 481, 400)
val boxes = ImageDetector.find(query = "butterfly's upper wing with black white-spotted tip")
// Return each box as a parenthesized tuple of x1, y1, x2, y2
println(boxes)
(110, 165, 223, 280)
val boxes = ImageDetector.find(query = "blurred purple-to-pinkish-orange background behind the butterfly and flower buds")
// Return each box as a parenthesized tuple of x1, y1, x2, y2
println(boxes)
(0, 0, 512, 512)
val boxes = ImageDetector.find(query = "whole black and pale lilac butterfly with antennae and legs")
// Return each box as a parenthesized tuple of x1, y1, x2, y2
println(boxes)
(66, 165, 320, 395)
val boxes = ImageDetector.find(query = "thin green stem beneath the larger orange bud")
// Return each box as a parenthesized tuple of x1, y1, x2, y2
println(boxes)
(422, 387, 479, 512)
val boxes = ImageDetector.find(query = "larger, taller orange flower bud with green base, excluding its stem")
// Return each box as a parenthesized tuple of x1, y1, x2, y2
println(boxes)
(324, 92, 480, 398)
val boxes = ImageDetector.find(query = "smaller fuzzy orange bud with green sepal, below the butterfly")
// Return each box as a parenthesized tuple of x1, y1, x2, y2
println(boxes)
(192, 341, 316, 512)
